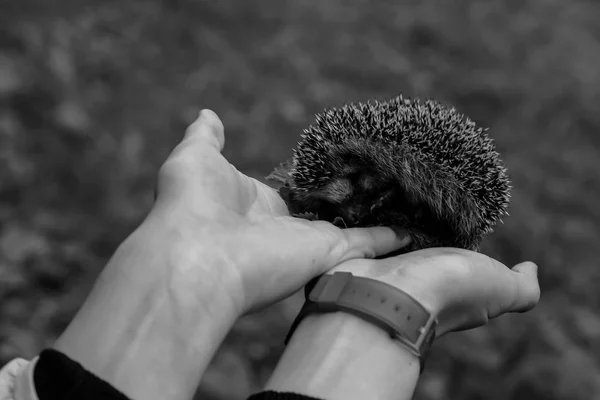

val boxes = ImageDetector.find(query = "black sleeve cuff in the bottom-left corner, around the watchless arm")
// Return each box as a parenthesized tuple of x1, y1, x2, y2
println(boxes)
(33, 349, 129, 400)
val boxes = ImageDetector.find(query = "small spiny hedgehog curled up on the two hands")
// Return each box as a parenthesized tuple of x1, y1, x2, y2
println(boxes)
(267, 96, 511, 252)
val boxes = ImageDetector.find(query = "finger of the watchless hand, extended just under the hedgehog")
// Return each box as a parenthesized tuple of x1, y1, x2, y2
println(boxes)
(338, 226, 411, 263)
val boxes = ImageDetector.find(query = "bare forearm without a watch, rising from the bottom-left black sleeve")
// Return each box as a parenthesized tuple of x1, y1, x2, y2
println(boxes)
(55, 219, 236, 400)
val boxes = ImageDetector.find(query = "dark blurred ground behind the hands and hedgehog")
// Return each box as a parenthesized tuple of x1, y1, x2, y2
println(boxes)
(0, 0, 600, 400)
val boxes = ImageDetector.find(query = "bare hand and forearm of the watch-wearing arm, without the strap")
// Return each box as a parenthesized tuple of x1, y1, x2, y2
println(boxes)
(266, 248, 540, 400)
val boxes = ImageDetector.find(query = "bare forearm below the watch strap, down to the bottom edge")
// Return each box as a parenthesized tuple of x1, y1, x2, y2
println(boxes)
(266, 312, 419, 400)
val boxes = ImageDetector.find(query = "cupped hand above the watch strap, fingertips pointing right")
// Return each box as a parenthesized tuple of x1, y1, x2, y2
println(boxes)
(330, 248, 540, 337)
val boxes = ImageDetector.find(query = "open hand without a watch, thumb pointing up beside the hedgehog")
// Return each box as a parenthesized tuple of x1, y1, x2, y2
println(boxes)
(145, 110, 410, 314)
